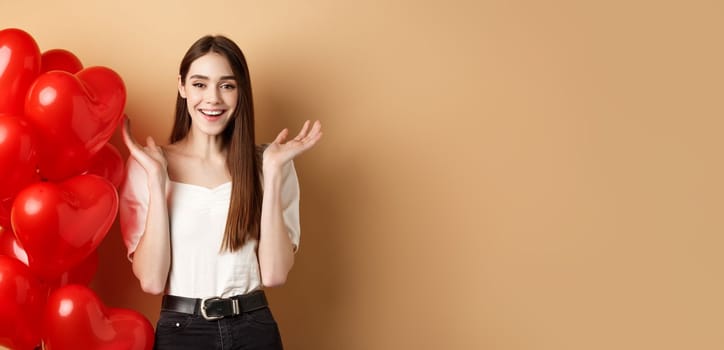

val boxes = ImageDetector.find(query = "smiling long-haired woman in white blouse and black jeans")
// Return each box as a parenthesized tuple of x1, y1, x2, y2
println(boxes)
(121, 36, 322, 349)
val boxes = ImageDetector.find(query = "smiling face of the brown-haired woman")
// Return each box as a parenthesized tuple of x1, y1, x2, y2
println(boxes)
(178, 52, 239, 135)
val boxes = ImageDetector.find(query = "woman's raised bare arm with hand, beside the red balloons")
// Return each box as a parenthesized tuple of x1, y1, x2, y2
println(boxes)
(123, 118, 171, 294)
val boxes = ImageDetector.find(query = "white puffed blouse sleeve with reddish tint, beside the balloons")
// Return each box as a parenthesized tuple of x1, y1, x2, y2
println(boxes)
(119, 157, 149, 260)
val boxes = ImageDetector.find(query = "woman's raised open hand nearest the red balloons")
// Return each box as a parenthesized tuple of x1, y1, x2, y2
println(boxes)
(122, 116, 168, 186)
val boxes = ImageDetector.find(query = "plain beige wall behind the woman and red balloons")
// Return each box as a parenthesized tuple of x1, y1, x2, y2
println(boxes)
(0, 0, 724, 350)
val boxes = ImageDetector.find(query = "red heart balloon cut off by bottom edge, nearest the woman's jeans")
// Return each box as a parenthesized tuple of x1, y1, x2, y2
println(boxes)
(43, 285, 153, 350)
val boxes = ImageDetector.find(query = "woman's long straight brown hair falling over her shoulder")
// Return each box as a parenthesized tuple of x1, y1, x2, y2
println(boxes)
(170, 35, 262, 251)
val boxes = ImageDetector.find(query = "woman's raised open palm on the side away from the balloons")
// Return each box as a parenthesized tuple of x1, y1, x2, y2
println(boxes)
(264, 120, 322, 169)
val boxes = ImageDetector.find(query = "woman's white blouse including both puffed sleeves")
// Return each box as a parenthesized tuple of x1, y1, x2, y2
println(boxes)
(120, 157, 300, 298)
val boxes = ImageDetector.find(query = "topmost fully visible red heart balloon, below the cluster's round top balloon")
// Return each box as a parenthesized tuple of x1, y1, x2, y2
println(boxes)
(25, 67, 126, 180)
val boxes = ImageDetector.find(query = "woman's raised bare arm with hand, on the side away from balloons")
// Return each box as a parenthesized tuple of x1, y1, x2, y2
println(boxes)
(258, 121, 322, 287)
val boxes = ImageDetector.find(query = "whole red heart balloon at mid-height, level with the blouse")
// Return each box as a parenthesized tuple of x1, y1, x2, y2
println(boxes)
(10, 175, 118, 281)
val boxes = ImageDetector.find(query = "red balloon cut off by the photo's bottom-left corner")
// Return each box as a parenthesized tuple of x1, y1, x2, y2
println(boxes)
(0, 256, 46, 350)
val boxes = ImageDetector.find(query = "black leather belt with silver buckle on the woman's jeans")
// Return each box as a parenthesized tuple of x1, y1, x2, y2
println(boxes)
(161, 290, 269, 321)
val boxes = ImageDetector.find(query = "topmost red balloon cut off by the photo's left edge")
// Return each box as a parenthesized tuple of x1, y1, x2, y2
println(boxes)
(0, 28, 40, 114)
